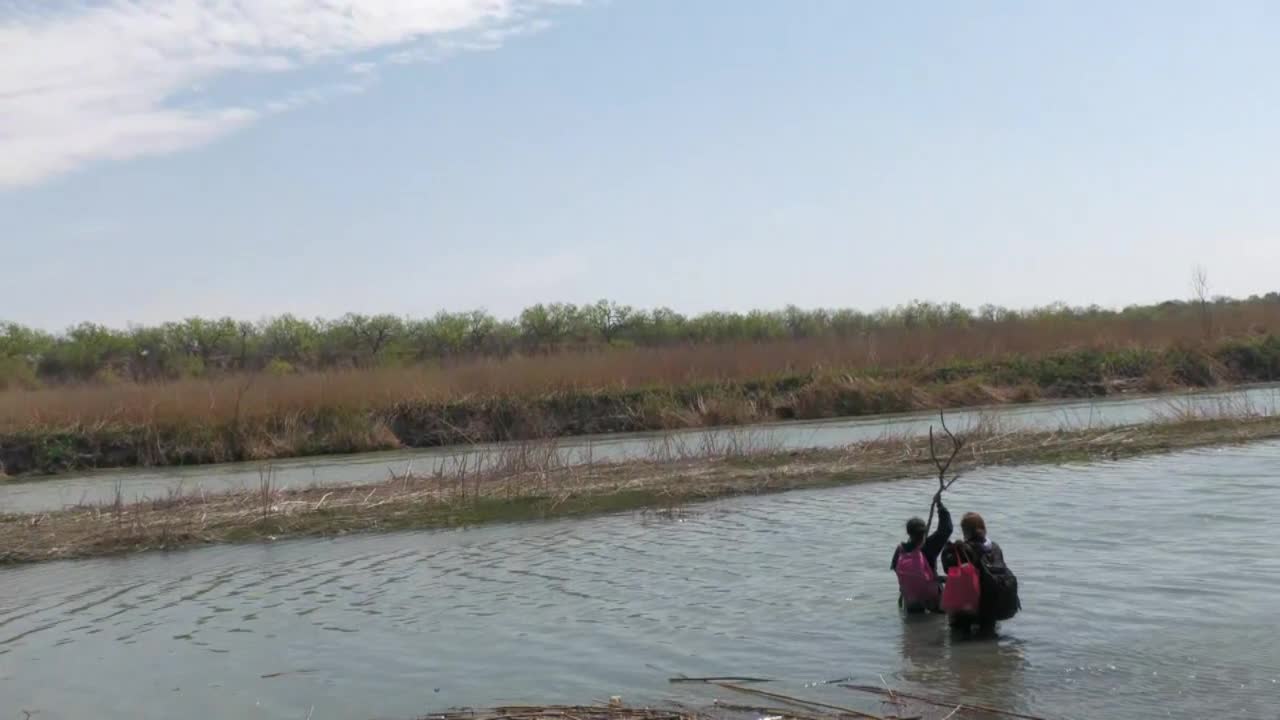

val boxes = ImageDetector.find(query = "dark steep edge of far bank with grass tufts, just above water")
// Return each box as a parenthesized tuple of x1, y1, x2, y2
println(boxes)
(0, 336, 1280, 475)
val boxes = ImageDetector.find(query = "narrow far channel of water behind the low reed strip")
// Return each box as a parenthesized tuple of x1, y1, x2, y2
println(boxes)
(0, 386, 1280, 512)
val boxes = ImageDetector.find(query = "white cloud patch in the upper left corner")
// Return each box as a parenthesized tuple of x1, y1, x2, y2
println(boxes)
(0, 0, 571, 190)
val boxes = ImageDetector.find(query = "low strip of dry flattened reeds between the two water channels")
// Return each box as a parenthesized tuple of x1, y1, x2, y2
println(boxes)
(0, 416, 1280, 564)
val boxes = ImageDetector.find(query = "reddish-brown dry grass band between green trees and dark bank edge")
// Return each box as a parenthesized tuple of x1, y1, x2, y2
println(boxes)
(0, 304, 1280, 429)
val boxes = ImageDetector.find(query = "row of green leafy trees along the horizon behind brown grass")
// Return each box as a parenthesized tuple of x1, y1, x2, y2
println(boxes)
(0, 292, 1280, 388)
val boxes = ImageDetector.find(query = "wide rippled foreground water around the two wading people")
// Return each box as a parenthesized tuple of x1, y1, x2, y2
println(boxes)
(0, 442, 1280, 720)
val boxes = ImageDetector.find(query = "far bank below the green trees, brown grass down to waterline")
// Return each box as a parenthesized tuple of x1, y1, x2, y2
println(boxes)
(0, 304, 1280, 475)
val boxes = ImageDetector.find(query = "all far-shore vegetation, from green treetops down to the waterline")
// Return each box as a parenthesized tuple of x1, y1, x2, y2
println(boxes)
(0, 288, 1280, 474)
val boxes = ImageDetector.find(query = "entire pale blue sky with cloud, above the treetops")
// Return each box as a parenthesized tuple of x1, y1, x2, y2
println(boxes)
(0, 0, 1280, 329)
